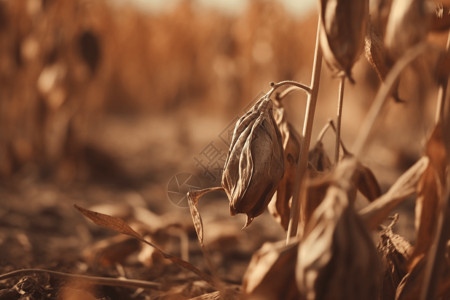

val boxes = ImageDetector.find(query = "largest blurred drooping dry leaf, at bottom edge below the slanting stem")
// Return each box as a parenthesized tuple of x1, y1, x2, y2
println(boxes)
(296, 158, 380, 299)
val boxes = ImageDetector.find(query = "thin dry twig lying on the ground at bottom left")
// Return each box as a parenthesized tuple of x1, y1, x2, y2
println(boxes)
(0, 269, 161, 289)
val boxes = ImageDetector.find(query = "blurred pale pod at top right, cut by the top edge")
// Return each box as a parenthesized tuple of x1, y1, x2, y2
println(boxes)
(384, 0, 428, 62)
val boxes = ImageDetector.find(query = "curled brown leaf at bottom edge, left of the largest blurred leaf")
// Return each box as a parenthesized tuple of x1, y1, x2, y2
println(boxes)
(242, 241, 300, 300)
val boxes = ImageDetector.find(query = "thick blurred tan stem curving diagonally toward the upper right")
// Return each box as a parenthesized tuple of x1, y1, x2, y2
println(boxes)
(353, 42, 430, 158)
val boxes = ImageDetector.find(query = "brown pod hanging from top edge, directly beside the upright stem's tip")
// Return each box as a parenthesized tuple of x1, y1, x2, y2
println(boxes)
(320, 0, 369, 81)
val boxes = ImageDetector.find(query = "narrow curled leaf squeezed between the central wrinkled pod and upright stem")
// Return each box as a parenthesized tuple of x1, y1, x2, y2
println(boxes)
(268, 107, 301, 230)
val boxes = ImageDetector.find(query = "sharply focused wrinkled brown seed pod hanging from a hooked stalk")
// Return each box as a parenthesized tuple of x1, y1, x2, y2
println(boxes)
(222, 96, 284, 227)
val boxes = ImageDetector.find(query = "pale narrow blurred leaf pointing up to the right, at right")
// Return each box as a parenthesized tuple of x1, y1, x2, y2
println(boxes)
(359, 157, 429, 230)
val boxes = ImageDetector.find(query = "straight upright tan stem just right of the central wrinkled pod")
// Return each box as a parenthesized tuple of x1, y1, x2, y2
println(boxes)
(286, 16, 322, 244)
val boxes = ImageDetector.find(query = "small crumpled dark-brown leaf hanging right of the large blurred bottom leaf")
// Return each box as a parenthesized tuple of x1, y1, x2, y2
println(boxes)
(377, 215, 412, 299)
